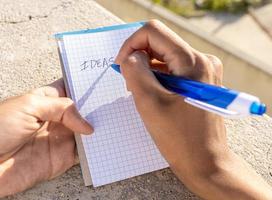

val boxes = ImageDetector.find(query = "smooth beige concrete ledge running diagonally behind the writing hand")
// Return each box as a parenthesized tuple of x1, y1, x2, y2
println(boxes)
(97, 0, 272, 115)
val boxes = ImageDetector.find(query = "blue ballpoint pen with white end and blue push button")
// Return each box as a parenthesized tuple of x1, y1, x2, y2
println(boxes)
(111, 64, 266, 117)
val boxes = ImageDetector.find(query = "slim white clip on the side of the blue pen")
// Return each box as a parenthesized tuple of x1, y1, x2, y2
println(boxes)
(184, 97, 246, 118)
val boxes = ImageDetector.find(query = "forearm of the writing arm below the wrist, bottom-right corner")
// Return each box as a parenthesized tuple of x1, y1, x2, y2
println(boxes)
(176, 153, 272, 200)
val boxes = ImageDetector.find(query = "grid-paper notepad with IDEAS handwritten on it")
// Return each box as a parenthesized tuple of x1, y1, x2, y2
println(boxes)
(56, 22, 168, 187)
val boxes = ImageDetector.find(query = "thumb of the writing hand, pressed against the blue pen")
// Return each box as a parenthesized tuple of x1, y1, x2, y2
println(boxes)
(120, 51, 169, 103)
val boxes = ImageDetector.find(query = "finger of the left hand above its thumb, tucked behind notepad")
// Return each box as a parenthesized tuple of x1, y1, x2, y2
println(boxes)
(30, 78, 66, 97)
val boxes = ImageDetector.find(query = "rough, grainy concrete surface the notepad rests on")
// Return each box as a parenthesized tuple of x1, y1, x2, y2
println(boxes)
(0, 0, 272, 200)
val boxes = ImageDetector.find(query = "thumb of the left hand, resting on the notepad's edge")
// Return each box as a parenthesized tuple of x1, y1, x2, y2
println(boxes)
(24, 94, 93, 134)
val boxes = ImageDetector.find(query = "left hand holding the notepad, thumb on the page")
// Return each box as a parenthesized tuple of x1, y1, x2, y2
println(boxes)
(0, 80, 93, 197)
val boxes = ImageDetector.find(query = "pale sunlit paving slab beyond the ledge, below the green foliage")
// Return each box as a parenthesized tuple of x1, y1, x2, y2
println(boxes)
(189, 10, 272, 70)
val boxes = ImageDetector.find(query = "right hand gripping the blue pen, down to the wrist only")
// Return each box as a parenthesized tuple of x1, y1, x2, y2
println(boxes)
(116, 20, 227, 179)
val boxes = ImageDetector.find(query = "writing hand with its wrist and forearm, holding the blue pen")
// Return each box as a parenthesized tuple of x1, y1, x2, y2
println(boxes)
(115, 20, 272, 199)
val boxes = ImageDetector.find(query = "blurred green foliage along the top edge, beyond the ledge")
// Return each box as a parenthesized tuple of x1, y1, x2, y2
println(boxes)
(152, 0, 266, 16)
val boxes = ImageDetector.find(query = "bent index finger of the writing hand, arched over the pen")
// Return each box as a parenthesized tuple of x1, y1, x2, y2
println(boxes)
(115, 20, 196, 76)
